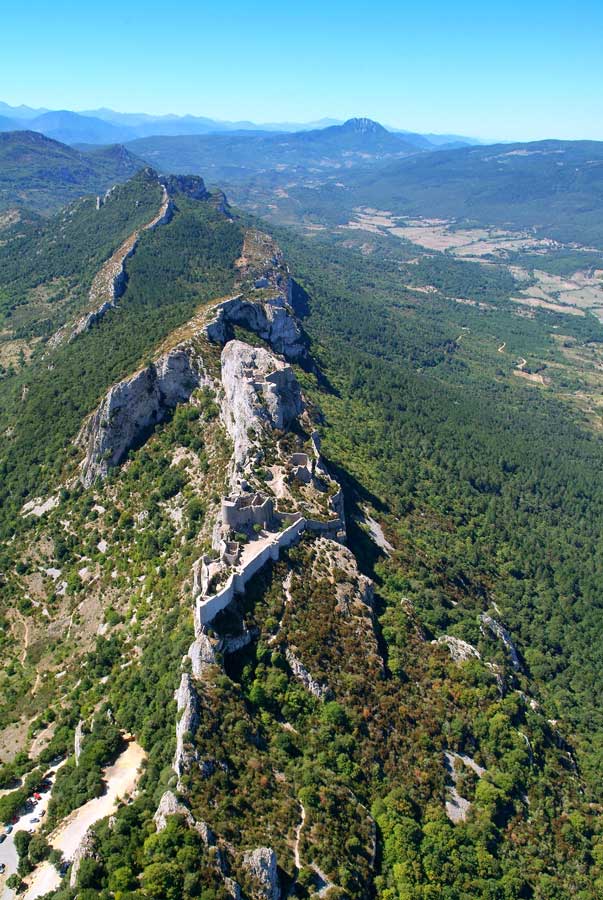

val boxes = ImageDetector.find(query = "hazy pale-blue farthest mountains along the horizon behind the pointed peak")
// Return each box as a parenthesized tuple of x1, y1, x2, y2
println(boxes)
(0, 101, 476, 149)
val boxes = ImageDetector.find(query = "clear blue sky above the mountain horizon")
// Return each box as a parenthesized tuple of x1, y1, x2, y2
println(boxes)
(0, 0, 603, 140)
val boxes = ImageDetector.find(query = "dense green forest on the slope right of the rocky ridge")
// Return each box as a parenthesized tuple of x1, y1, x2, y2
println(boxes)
(287, 230, 603, 799)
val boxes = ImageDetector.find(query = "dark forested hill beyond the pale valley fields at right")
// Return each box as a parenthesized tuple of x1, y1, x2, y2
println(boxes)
(332, 141, 603, 248)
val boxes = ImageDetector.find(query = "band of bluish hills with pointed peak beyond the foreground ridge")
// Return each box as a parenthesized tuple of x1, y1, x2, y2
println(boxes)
(0, 124, 603, 247)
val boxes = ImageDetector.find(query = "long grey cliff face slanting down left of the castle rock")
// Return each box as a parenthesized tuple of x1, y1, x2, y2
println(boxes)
(78, 346, 209, 487)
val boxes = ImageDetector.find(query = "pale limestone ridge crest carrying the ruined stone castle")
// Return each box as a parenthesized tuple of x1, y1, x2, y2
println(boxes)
(79, 223, 372, 900)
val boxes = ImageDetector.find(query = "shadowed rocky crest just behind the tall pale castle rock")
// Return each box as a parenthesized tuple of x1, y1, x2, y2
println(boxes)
(205, 287, 306, 360)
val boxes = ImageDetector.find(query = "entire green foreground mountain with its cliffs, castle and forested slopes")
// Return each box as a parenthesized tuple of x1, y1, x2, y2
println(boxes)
(0, 156, 603, 900)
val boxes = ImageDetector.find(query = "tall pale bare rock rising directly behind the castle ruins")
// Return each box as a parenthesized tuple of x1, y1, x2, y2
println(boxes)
(222, 341, 303, 464)
